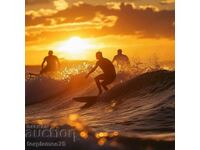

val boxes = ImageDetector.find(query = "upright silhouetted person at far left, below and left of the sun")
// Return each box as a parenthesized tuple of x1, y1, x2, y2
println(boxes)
(40, 50, 60, 74)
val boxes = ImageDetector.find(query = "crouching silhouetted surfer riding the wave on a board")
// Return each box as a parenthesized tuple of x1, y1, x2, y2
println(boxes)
(86, 52, 116, 95)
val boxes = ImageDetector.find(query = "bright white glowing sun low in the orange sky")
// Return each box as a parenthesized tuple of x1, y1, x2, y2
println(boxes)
(57, 37, 91, 55)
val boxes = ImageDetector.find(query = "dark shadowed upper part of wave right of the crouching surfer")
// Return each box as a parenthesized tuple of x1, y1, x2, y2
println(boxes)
(101, 70, 175, 101)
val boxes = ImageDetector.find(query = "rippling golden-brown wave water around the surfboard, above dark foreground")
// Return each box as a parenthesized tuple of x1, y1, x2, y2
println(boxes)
(26, 64, 175, 149)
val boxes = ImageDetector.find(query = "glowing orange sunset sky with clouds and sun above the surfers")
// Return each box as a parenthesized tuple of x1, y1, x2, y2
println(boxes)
(25, 0, 175, 65)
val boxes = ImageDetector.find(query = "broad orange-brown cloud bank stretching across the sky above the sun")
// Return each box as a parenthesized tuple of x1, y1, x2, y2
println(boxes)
(26, 3, 175, 40)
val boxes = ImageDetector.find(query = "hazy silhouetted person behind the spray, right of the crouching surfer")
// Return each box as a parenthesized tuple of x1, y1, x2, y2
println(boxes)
(112, 49, 130, 68)
